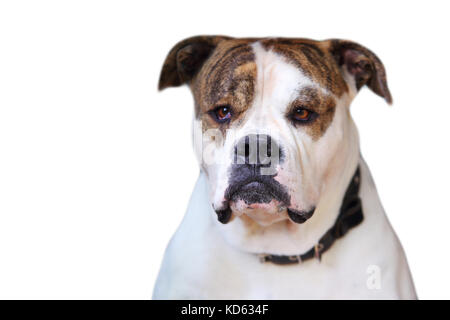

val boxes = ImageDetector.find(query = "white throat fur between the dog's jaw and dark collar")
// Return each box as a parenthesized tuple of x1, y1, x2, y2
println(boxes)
(206, 121, 360, 255)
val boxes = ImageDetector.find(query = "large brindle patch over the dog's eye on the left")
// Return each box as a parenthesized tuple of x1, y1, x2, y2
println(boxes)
(191, 39, 256, 134)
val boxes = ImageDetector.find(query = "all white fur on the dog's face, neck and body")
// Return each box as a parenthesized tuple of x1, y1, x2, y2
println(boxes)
(154, 43, 416, 299)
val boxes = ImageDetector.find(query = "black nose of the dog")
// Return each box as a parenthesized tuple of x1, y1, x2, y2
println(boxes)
(234, 134, 283, 167)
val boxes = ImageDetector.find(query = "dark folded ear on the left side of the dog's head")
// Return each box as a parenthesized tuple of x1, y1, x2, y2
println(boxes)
(158, 36, 230, 90)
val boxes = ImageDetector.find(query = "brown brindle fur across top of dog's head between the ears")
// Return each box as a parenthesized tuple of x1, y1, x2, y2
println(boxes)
(193, 38, 347, 111)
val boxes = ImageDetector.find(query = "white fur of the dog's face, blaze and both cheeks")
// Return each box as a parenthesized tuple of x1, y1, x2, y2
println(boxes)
(194, 42, 352, 225)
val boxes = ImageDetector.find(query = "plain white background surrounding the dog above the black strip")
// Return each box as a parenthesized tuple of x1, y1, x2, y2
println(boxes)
(0, 0, 450, 299)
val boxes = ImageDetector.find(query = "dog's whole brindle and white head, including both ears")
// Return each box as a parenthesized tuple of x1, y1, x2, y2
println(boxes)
(159, 36, 391, 226)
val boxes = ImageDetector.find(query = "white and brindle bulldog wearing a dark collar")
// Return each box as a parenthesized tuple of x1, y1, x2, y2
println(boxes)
(153, 36, 417, 299)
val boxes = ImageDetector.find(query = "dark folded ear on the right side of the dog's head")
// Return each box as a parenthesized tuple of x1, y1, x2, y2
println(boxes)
(330, 39, 392, 104)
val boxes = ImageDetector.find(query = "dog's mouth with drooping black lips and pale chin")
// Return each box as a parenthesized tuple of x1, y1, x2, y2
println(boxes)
(216, 176, 314, 225)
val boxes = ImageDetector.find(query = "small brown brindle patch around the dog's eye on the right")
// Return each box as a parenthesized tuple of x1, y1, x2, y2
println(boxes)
(286, 87, 336, 140)
